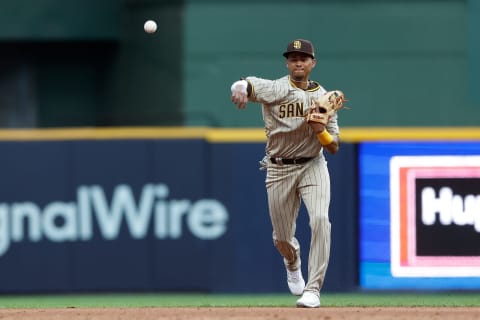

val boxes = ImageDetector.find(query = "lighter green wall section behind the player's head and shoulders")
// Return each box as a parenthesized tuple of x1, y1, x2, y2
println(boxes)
(184, 0, 480, 126)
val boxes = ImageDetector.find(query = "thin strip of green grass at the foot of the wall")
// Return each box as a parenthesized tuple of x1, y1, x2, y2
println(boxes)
(0, 293, 480, 308)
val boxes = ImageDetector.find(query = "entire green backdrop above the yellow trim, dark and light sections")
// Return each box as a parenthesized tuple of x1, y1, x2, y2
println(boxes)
(0, 0, 480, 127)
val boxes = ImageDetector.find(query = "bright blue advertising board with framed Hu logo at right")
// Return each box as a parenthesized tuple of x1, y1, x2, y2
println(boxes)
(359, 142, 480, 289)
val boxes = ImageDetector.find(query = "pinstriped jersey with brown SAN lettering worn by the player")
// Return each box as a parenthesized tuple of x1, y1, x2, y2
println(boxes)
(245, 75, 339, 158)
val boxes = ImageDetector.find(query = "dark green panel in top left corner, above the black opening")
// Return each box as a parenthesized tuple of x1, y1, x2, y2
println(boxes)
(0, 0, 123, 41)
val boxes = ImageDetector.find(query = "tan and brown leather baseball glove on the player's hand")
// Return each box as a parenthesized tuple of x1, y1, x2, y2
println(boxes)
(305, 90, 347, 133)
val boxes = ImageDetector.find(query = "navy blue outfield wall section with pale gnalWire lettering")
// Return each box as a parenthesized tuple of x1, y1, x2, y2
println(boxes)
(0, 129, 356, 293)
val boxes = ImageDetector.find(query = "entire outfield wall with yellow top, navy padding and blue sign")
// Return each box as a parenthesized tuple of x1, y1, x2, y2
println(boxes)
(0, 127, 480, 293)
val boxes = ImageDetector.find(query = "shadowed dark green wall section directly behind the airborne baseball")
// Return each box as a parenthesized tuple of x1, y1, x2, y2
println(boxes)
(106, 0, 183, 125)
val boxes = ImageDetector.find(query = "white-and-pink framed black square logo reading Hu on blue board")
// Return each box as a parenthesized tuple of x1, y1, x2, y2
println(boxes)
(390, 156, 480, 277)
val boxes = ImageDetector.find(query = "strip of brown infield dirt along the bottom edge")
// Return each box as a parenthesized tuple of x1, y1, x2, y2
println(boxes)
(0, 307, 480, 320)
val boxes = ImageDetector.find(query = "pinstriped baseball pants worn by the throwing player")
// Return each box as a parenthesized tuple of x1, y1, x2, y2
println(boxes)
(265, 157, 330, 292)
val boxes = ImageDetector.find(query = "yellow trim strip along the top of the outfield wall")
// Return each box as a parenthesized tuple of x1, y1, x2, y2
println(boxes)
(0, 127, 480, 143)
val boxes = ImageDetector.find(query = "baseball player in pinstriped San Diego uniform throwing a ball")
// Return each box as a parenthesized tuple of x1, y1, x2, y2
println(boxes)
(231, 39, 344, 308)
